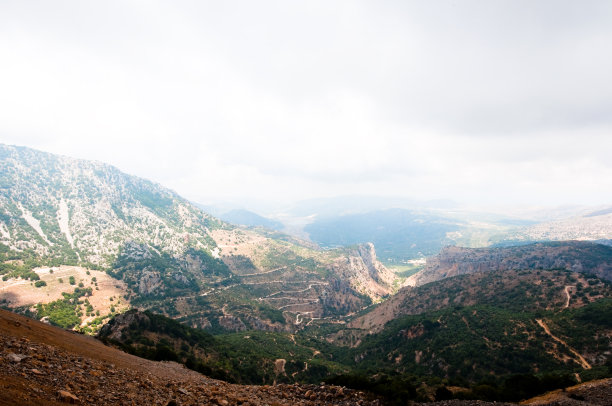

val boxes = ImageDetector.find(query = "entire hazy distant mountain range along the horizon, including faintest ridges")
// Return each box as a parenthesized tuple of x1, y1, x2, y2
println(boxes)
(201, 196, 612, 266)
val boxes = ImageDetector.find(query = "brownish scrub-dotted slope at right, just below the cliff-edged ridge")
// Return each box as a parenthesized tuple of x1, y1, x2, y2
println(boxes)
(348, 270, 612, 331)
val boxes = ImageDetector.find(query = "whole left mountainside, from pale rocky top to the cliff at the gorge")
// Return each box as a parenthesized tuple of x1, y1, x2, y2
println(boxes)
(0, 145, 394, 332)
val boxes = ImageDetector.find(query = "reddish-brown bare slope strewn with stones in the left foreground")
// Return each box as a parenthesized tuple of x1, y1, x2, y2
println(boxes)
(0, 310, 380, 406)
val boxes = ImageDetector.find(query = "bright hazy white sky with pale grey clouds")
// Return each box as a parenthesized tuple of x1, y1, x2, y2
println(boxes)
(0, 0, 612, 209)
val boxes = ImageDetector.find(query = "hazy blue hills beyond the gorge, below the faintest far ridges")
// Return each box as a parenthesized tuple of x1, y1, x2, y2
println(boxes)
(304, 208, 612, 264)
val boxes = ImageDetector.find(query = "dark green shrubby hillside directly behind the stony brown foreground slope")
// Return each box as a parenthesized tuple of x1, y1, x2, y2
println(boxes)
(97, 310, 348, 385)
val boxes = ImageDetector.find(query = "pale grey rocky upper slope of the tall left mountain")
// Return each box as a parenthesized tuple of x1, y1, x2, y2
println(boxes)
(0, 146, 221, 267)
